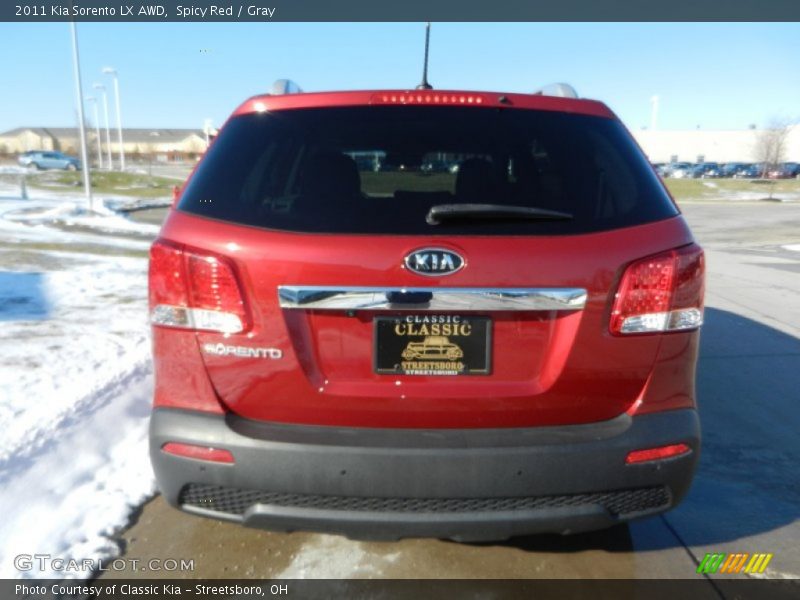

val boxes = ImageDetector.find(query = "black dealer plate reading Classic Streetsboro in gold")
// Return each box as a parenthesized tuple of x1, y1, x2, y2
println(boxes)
(373, 315, 492, 375)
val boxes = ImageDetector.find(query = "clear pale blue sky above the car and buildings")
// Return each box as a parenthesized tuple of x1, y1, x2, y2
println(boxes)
(0, 22, 800, 132)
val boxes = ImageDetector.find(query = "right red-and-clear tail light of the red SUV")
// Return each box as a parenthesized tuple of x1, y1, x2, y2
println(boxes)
(610, 244, 705, 335)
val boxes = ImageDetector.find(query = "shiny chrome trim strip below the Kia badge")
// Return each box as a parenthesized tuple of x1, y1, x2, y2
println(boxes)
(278, 285, 586, 312)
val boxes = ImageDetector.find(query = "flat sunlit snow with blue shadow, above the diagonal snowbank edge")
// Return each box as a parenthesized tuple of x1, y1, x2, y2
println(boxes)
(0, 257, 150, 464)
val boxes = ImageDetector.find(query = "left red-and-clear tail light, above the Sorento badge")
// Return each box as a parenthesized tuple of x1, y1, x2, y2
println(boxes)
(150, 240, 249, 333)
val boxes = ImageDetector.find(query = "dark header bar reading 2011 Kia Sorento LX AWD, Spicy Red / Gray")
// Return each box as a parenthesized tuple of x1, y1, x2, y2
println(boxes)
(0, 0, 800, 23)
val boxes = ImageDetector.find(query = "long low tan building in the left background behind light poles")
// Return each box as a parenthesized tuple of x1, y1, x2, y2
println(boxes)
(0, 127, 206, 161)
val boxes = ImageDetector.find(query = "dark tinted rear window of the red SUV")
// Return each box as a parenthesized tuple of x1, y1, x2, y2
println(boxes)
(179, 106, 677, 235)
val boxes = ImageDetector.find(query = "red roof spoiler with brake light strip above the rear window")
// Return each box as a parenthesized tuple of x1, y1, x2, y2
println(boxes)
(233, 89, 617, 119)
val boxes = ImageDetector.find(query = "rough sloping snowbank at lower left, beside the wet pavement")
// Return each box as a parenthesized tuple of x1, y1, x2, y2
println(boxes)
(0, 364, 155, 578)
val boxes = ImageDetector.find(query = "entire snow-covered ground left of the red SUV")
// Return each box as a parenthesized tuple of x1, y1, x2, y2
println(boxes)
(0, 184, 158, 577)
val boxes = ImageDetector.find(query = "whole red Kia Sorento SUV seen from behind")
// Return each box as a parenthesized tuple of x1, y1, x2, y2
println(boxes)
(150, 82, 704, 540)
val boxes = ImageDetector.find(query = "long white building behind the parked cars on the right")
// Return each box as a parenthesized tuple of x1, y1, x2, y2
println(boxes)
(633, 124, 800, 163)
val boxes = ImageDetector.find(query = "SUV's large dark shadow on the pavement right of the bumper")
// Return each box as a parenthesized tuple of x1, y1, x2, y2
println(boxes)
(488, 308, 800, 552)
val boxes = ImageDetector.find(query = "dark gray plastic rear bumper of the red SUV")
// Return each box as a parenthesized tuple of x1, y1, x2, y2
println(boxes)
(150, 409, 700, 540)
